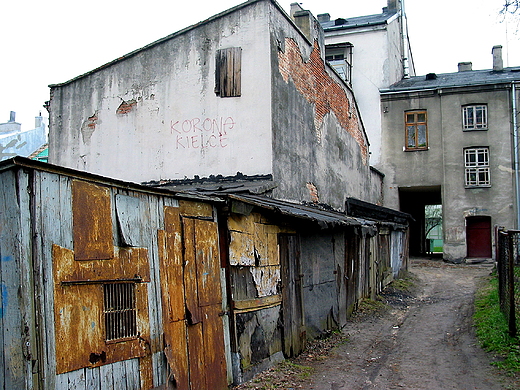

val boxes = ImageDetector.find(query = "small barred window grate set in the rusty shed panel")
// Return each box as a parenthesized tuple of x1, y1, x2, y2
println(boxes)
(103, 283, 137, 341)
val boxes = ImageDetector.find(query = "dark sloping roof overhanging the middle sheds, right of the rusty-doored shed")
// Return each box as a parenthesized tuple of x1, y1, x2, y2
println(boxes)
(228, 194, 376, 229)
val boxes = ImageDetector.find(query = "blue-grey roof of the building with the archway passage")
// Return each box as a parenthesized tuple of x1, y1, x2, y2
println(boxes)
(381, 67, 520, 93)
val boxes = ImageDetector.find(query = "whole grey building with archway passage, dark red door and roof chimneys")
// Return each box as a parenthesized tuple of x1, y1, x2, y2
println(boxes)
(381, 46, 520, 262)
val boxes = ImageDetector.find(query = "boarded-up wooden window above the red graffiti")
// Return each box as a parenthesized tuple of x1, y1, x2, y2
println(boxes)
(215, 47, 242, 97)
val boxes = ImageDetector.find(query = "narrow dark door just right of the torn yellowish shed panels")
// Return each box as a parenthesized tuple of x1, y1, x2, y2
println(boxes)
(279, 234, 306, 357)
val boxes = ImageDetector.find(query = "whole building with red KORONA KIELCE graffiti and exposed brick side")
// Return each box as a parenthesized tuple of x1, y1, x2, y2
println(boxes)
(49, 0, 382, 209)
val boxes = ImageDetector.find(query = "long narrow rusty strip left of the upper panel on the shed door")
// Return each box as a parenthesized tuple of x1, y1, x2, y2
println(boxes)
(182, 218, 202, 324)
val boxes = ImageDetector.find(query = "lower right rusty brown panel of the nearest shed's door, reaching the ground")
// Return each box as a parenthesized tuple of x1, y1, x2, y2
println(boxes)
(202, 304, 228, 390)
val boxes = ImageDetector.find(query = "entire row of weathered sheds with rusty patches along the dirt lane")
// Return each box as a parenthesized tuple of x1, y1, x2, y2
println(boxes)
(0, 158, 407, 390)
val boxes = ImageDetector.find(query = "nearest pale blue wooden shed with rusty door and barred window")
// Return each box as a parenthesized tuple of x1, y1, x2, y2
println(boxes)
(0, 157, 231, 390)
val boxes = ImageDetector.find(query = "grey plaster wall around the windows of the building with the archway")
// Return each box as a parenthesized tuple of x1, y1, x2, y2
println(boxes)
(382, 87, 515, 261)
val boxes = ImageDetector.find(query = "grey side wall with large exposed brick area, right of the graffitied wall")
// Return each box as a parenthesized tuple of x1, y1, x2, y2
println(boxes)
(271, 12, 379, 209)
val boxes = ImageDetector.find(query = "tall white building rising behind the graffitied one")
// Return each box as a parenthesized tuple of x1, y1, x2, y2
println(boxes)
(316, 0, 415, 166)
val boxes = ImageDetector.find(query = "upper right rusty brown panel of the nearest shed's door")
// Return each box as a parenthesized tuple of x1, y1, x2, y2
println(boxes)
(195, 219, 222, 306)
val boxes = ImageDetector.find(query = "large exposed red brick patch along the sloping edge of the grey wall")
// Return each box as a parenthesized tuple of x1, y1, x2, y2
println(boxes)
(278, 38, 368, 165)
